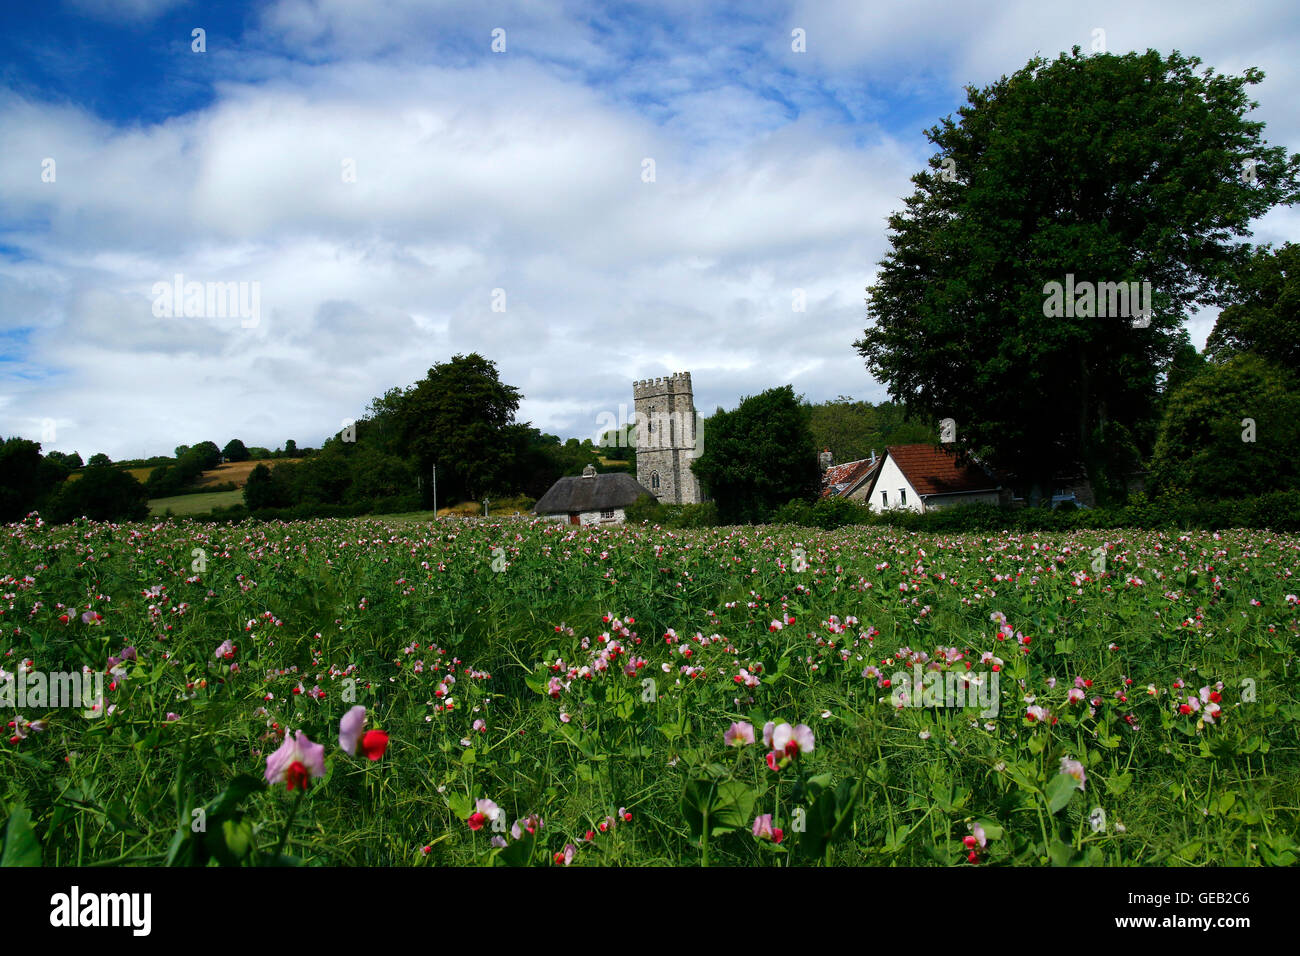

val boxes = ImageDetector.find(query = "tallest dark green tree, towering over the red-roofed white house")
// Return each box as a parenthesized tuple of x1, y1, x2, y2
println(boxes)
(855, 48, 1300, 497)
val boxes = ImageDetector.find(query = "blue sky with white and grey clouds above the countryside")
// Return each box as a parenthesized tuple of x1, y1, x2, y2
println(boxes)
(0, 0, 1300, 458)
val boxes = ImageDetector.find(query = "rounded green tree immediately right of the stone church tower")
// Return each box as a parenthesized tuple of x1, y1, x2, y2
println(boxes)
(690, 385, 819, 523)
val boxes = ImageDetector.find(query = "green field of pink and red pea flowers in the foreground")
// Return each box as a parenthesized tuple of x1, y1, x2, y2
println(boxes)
(0, 516, 1300, 866)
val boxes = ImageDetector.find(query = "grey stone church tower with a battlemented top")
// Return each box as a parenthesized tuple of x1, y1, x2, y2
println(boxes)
(632, 372, 703, 505)
